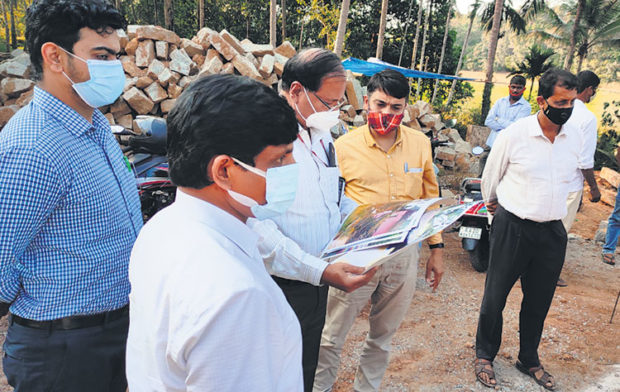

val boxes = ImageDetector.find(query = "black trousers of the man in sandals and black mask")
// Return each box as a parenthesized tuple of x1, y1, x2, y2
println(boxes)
(476, 206, 567, 368)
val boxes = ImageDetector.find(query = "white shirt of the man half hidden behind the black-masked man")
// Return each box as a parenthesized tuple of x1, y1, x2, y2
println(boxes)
(568, 99, 598, 192)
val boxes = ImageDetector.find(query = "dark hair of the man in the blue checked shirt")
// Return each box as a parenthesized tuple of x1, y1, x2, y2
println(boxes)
(25, 0, 125, 79)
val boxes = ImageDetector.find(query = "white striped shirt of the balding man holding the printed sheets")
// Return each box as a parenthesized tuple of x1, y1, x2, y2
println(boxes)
(247, 126, 357, 285)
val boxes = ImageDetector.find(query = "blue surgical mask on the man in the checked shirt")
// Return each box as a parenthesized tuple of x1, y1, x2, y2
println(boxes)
(61, 48, 125, 108)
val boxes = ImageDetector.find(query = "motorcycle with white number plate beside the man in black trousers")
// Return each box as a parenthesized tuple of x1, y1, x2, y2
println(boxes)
(458, 147, 490, 272)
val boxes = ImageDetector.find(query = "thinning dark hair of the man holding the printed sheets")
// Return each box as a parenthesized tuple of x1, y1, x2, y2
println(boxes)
(282, 48, 346, 91)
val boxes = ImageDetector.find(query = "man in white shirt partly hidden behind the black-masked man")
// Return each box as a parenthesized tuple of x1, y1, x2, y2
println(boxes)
(558, 71, 601, 287)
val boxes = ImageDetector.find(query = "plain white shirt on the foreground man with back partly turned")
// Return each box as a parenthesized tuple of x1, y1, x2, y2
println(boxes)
(127, 190, 303, 392)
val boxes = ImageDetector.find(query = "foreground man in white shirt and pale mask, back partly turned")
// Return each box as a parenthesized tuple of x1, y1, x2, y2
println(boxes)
(127, 75, 303, 392)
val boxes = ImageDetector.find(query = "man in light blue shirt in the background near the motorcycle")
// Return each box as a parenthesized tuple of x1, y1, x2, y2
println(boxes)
(484, 75, 532, 148)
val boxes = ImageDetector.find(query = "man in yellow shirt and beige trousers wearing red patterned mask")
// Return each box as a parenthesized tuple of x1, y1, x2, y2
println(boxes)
(314, 70, 444, 391)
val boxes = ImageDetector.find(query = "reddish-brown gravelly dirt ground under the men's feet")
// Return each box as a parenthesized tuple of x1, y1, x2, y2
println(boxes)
(0, 196, 620, 392)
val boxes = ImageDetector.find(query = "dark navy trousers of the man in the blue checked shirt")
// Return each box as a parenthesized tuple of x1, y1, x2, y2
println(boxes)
(2, 314, 129, 392)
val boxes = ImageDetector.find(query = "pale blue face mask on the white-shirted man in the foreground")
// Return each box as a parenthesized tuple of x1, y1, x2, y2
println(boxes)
(228, 158, 299, 220)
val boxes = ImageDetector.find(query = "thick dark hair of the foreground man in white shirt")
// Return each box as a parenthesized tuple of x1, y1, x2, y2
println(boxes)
(167, 75, 298, 189)
